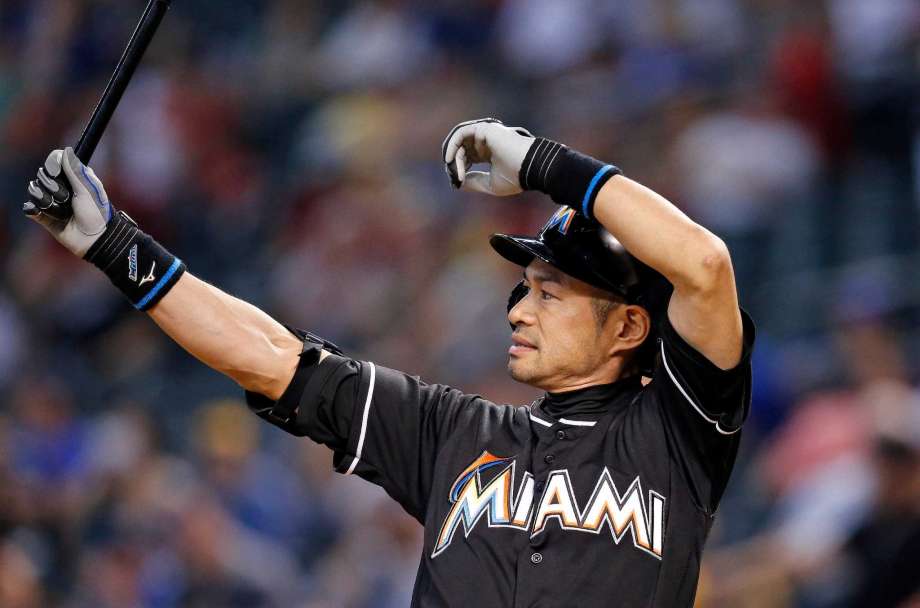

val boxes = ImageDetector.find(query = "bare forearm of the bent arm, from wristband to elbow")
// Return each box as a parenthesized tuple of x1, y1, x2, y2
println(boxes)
(594, 175, 731, 291)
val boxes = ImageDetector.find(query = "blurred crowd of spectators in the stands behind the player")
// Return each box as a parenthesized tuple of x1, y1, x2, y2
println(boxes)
(0, 0, 920, 608)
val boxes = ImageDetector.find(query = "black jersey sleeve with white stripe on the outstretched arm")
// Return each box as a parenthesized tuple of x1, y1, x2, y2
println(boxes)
(247, 354, 489, 521)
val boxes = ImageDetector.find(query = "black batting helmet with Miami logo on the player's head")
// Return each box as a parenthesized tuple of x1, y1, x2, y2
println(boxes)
(489, 206, 672, 376)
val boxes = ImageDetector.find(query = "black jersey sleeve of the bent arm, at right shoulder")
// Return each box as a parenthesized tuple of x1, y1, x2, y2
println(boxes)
(649, 310, 755, 511)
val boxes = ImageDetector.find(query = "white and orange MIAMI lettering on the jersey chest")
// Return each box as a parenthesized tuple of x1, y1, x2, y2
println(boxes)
(431, 451, 665, 559)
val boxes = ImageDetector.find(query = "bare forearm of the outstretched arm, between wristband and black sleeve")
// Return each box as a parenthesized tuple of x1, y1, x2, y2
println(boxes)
(149, 273, 303, 399)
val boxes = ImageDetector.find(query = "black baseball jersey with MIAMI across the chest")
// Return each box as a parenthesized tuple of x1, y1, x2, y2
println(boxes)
(249, 313, 754, 608)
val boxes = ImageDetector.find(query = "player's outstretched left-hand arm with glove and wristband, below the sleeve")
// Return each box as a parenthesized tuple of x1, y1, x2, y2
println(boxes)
(23, 148, 303, 400)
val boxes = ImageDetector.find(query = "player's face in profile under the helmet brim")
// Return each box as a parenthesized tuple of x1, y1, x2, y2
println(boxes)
(508, 259, 644, 392)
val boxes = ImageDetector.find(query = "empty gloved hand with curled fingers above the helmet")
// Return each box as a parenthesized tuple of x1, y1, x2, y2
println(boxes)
(442, 118, 535, 196)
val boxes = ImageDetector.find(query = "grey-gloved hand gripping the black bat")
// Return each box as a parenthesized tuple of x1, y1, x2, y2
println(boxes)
(22, 148, 114, 258)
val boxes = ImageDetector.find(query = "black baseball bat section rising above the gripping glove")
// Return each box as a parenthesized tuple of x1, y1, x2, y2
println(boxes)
(74, 0, 170, 164)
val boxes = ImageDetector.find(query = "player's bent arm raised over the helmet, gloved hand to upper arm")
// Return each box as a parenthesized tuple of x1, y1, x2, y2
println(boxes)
(442, 119, 743, 369)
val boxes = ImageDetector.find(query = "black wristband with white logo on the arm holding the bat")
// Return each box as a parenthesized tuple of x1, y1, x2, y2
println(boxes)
(83, 211, 185, 310)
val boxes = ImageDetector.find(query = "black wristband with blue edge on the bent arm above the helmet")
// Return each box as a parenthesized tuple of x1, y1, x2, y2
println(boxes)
(518, 137, 622, 219)
